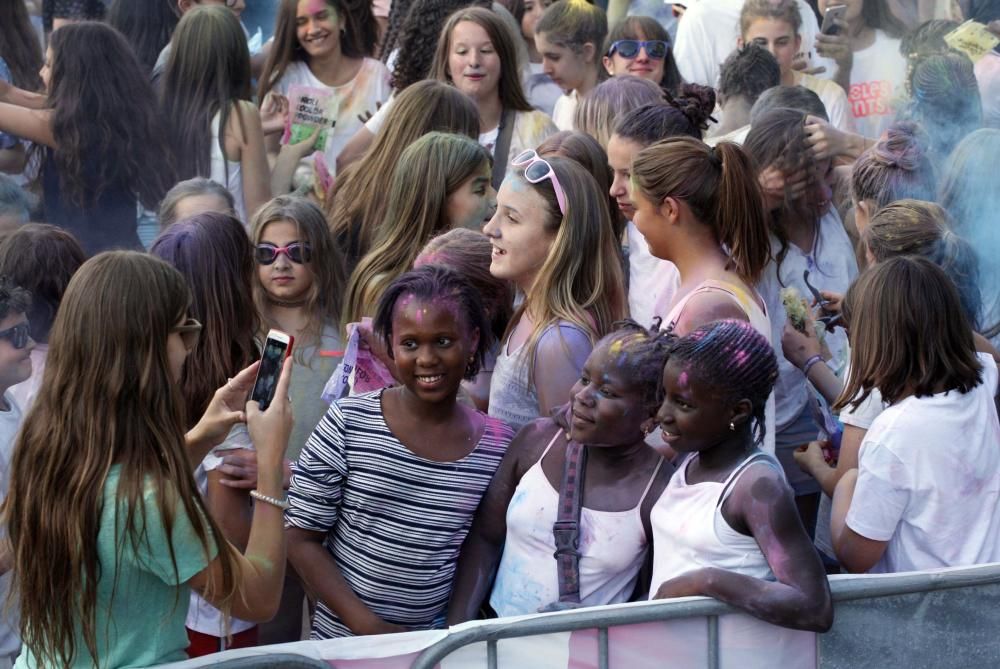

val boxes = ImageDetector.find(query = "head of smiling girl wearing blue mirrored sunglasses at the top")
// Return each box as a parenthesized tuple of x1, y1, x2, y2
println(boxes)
(603, 16, 684, 94)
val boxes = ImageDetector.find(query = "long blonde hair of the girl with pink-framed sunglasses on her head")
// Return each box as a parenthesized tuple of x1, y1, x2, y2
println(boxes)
(504, 157, 627, 384)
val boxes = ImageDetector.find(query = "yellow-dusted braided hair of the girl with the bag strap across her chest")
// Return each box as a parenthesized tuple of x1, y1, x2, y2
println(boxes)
(594, 319, 677, 413)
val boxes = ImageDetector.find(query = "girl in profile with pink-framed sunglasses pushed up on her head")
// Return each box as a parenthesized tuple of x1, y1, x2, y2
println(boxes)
(483, 151, 627, 429)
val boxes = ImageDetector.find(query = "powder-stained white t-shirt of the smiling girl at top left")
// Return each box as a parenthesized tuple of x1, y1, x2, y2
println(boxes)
(274, 58, 392, 172)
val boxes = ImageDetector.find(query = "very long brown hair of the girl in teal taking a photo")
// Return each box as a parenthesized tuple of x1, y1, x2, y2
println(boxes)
(3, 251, 238, 666)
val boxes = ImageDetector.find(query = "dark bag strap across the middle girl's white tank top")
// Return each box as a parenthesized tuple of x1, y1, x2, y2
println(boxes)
(552, 441, 587, 602)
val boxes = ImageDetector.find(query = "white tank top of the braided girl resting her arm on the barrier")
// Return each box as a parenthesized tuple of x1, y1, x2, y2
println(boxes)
(649, 453, 782, 598)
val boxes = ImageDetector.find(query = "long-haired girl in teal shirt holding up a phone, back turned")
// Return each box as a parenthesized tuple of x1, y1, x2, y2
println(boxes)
(3, 252, 292, 667)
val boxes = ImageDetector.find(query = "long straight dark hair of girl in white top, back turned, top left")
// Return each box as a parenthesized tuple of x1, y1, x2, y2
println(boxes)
(162, 5, 251, 180)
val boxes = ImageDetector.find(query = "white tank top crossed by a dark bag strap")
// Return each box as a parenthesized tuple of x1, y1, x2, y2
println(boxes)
(490, 430, 663, 617)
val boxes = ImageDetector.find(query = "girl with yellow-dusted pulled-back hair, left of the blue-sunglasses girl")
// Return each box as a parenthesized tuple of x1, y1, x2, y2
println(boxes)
(535, 0, 608, 130)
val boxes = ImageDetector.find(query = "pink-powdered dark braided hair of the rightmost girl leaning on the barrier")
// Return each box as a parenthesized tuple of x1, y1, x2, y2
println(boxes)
(668, 319, 778, 444)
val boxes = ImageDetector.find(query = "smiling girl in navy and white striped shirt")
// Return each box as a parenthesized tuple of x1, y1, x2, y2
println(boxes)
(285, 265, 513, 639)
